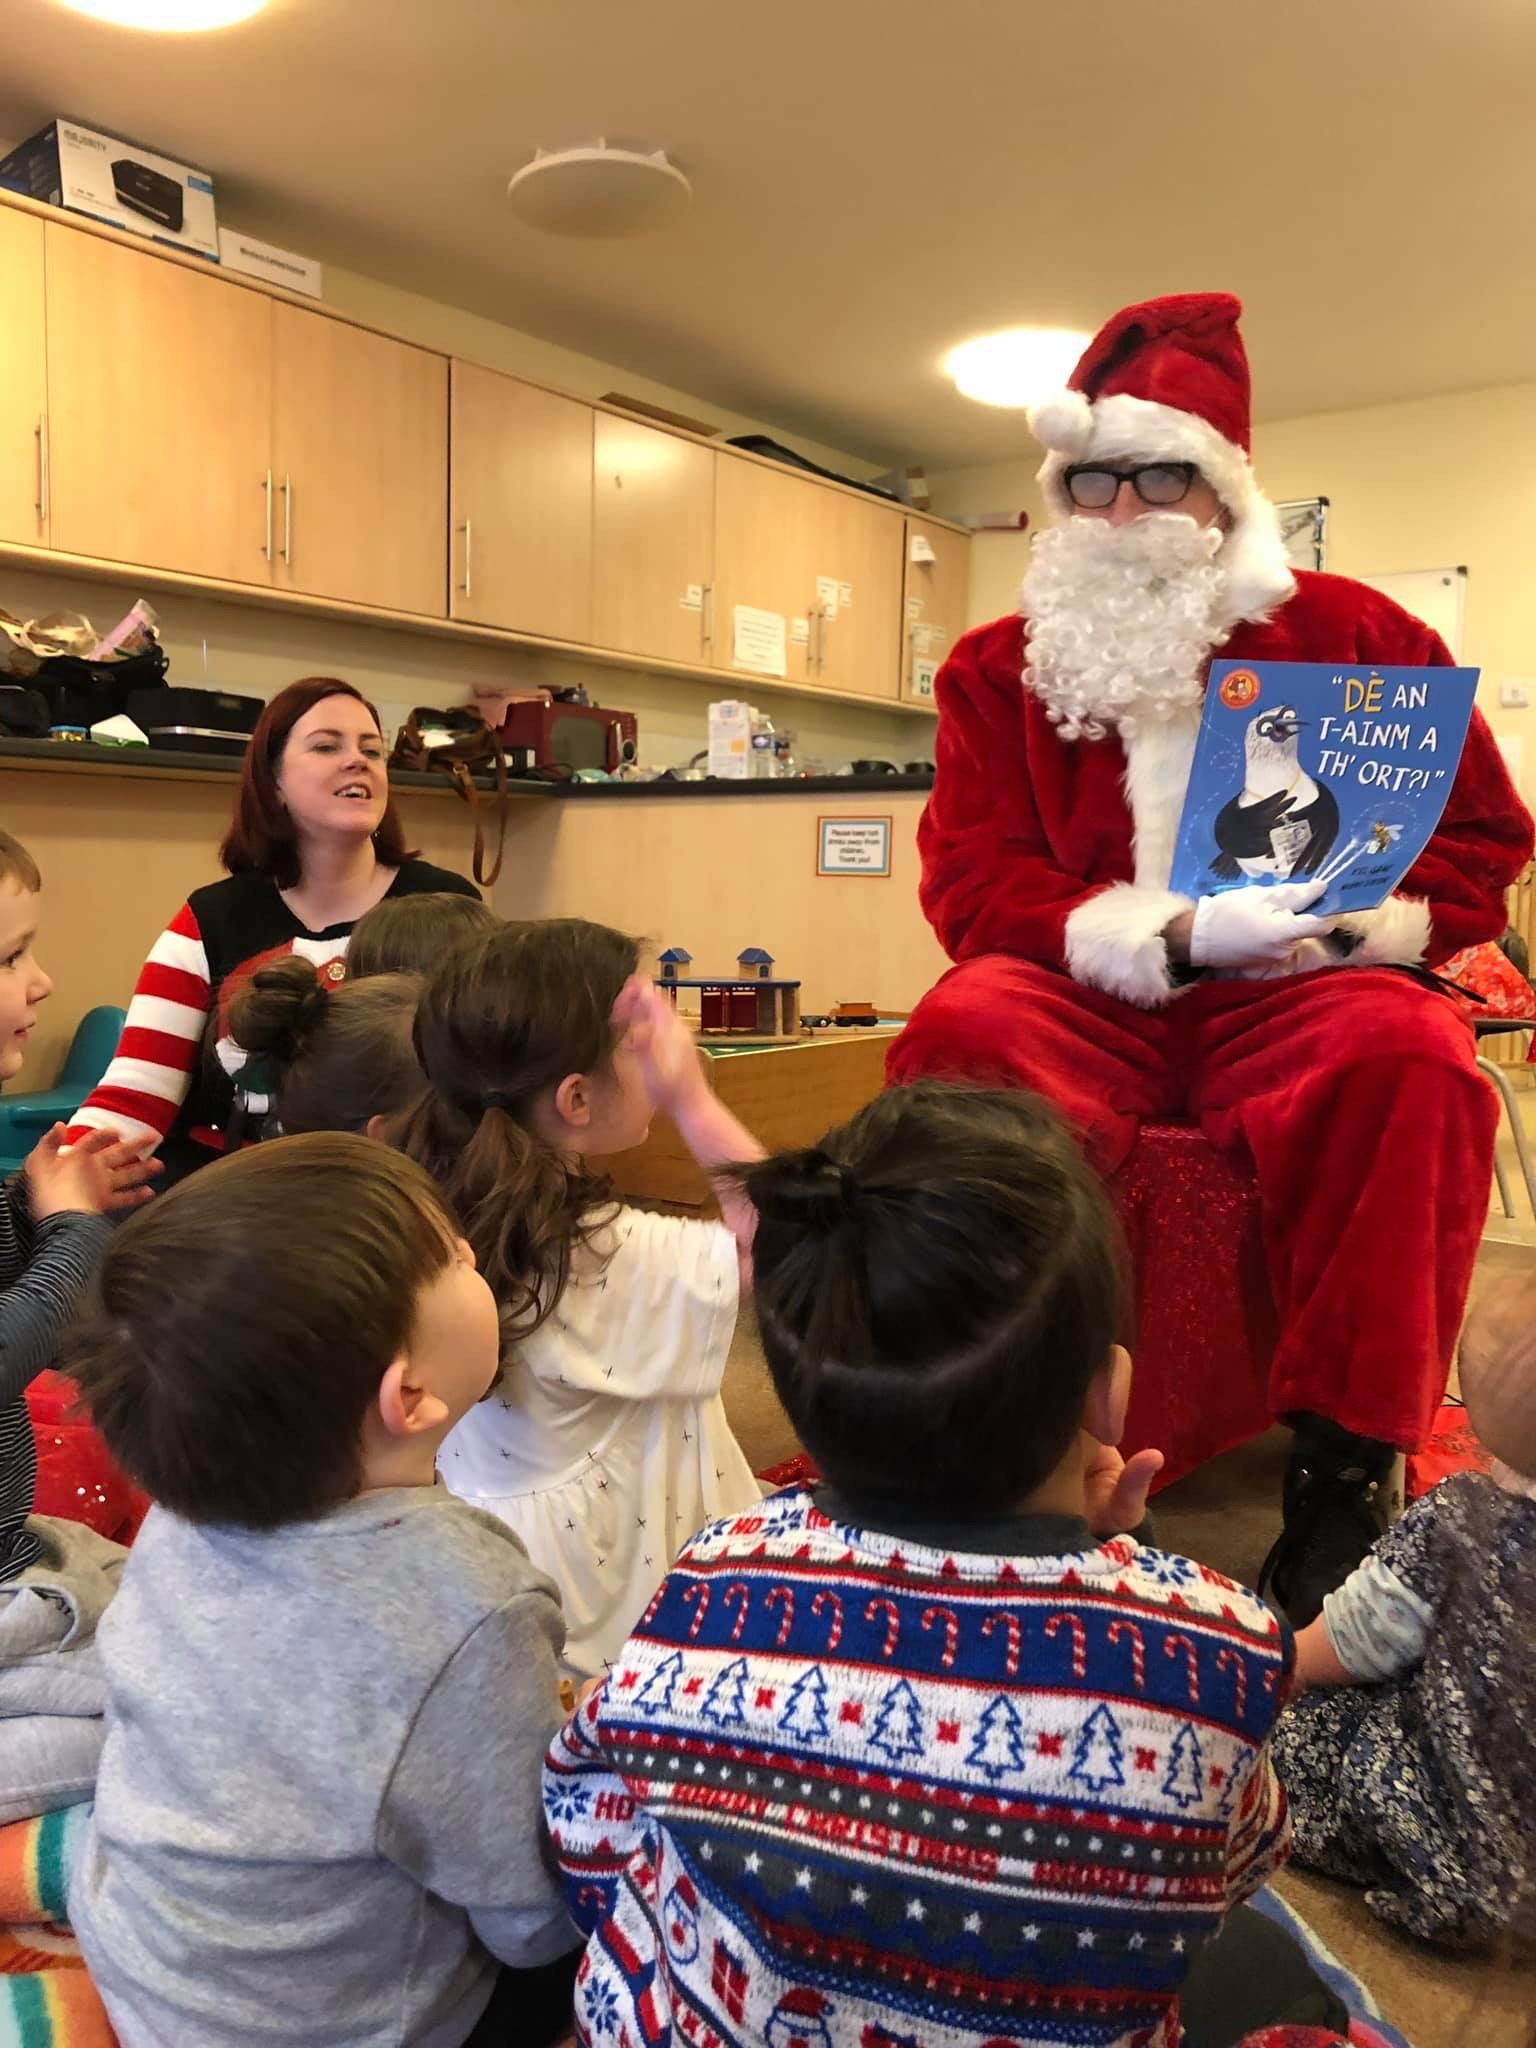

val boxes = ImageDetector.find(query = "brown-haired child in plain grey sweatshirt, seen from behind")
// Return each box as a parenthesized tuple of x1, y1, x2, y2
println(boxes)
(70, 1135, 578, 2048)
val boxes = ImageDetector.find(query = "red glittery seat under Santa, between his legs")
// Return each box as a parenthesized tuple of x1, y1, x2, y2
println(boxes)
(1110, 1124, 1276, 1485)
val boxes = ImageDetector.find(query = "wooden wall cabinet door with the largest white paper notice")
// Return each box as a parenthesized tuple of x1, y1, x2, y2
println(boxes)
(711, 455, 836, 682)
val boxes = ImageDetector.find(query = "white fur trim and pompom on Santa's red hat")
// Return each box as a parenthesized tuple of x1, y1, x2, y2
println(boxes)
(1030, 391, 1296, 625)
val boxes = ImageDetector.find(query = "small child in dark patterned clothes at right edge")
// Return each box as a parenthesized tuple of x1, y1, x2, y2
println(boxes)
(1274, 1280, 1536, 1948)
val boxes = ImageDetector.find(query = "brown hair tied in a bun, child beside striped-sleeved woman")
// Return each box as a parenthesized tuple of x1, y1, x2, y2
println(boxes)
(227, 954, 426, 1133)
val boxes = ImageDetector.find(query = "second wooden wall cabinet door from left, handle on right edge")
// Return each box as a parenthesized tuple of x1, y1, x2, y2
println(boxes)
(45, 221, 276, 584)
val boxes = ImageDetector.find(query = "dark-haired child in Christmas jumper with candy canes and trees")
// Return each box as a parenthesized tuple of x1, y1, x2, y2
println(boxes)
(545, 1083, 1327, 2048)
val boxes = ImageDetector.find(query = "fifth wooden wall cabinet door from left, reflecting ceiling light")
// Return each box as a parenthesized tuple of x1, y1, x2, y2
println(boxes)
(592, 412, 715, 662)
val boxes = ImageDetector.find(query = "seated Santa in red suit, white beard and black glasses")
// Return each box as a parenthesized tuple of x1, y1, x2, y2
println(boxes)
(889, 293, 1532, 1624)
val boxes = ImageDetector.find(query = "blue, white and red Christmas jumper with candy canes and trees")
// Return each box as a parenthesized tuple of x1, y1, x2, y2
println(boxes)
(547, 1491, 1290, 2048)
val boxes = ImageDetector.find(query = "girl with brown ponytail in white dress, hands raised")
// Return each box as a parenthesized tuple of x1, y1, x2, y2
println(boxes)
(391, 918, 762, 1679)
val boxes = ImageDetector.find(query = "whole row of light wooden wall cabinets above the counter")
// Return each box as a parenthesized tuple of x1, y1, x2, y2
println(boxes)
(0, 201, 969, 702)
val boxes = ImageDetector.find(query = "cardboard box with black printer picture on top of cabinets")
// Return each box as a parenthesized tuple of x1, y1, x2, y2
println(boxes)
(0, 121, 219, 262)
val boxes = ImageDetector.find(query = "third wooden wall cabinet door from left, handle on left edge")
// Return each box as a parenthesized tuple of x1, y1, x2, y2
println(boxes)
(272, 301, 449, 618)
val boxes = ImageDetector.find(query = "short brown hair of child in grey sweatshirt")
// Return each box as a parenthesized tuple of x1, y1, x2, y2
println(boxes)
(66, 1130, 457, 1530)
